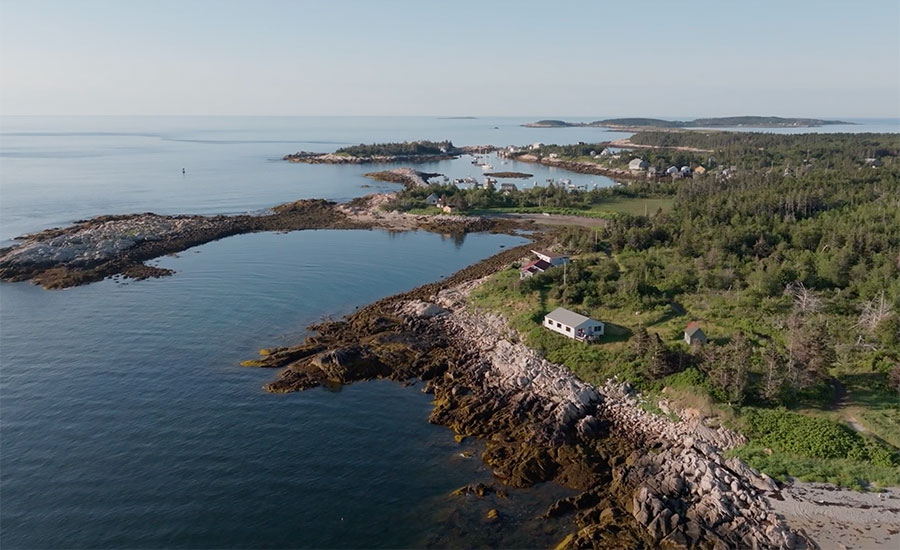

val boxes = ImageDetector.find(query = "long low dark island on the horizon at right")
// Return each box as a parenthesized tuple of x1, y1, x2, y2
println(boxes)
(523, 116, 853, 128)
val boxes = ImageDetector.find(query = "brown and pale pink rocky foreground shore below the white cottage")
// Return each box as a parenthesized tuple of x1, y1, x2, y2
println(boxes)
(244, 251, 815, 548)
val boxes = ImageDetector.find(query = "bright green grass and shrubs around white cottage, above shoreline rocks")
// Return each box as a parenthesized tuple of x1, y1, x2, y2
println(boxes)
(470, 264, 900, 489)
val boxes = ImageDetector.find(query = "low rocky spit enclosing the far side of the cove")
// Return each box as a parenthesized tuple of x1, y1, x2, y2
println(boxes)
(0, 194, 521, 289)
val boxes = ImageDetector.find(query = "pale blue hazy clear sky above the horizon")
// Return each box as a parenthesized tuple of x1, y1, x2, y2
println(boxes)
(0, 0, 900, 118)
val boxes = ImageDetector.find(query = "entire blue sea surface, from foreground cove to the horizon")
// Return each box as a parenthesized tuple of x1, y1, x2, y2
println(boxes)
(0, 117, 896, 548)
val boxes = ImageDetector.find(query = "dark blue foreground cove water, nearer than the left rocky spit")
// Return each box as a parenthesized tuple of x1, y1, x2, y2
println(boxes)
(0, 231, 584, 548)
